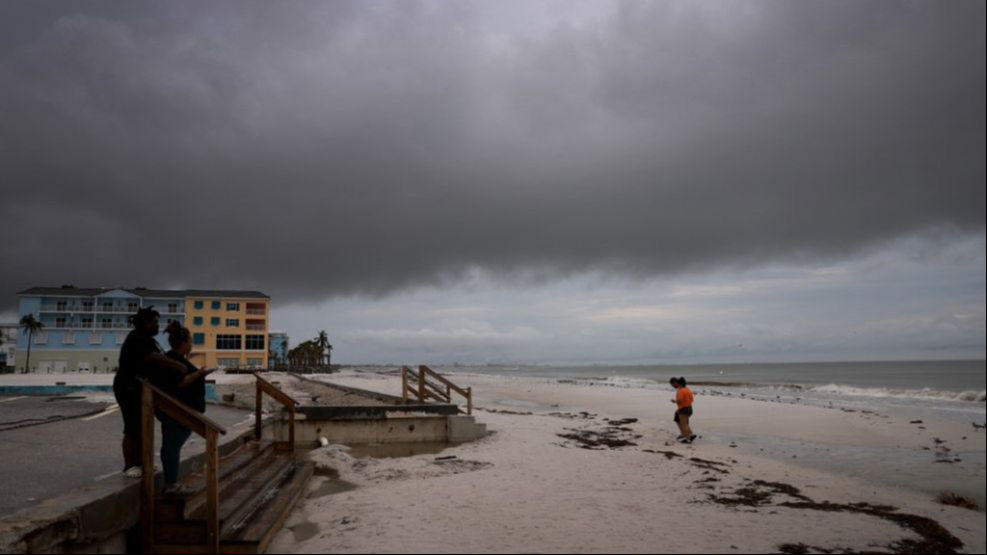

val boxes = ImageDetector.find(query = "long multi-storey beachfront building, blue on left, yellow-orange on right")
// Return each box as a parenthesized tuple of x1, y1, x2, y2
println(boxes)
(17, 287, 271, 374)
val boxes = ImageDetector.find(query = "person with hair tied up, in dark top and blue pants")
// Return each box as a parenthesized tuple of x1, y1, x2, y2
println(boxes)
(155, 322, 211, 495)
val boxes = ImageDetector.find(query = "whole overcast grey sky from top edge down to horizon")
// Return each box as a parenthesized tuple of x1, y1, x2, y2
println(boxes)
(0, 0, 987, 363)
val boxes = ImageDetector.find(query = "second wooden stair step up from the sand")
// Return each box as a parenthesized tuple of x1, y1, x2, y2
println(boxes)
(155, 451, 297, 545)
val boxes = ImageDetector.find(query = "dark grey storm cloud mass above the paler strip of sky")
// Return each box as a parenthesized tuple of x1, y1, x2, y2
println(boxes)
(0, 0, 987, 305)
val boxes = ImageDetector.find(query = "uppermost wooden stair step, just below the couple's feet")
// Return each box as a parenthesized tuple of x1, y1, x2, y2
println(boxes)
(155, 441, 275, 523)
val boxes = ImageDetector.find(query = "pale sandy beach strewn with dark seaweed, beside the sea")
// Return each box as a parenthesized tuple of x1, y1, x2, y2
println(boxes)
(272, 371, 985, 553)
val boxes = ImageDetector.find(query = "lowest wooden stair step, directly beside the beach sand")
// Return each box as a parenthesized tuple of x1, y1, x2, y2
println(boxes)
(154, 463, 315, 555)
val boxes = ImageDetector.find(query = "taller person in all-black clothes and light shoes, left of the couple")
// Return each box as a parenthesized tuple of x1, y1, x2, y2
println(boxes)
(113, 308, 185, 479)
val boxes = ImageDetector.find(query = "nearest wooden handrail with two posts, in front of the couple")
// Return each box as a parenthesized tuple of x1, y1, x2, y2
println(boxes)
(139, 380, 226, 553)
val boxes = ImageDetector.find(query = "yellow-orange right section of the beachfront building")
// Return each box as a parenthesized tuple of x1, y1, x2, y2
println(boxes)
(185, 291, 271, 369)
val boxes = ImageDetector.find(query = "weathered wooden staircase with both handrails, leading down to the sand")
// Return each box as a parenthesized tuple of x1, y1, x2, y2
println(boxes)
(142, 376, 314, 555)
